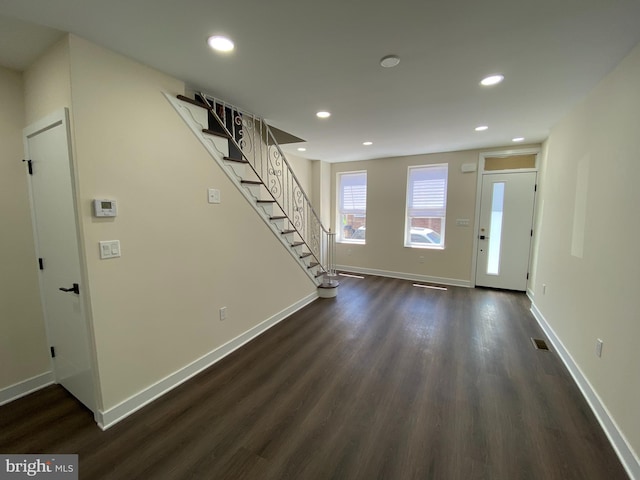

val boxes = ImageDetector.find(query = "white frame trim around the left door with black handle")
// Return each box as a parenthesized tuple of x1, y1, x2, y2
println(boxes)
(22, 107, 102, 420)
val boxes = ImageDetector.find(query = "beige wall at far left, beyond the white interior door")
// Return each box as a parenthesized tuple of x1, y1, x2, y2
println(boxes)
(0, 67, 51, 390)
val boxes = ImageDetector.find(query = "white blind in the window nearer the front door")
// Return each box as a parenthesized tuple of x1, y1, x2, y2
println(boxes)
(407, 164, 448, 217)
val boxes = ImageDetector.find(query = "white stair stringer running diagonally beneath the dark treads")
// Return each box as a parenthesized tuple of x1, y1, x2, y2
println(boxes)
(162, 92, 323, 286)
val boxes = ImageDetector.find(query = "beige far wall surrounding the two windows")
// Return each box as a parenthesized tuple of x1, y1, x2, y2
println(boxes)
(331, 149, 524, 285)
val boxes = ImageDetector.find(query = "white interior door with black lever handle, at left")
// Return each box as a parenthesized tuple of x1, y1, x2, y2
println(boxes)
(24, 109, 95, 411)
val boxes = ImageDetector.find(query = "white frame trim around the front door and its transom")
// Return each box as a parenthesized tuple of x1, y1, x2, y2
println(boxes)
(470, 147, 542, 288)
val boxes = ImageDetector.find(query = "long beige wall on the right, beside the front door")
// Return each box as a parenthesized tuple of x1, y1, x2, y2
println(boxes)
(533, 46, 640, 467)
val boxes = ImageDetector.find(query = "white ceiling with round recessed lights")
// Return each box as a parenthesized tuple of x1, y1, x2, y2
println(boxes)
(0, 0, 640, 162)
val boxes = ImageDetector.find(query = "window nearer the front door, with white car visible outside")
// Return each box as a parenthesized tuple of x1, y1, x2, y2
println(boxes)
(404, 163, 448, 248)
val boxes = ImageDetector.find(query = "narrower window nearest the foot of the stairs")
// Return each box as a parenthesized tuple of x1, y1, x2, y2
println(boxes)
(338, 172, 367, 243)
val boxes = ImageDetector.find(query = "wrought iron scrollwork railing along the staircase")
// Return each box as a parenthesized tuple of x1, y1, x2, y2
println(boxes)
(191, 93, 338, 287)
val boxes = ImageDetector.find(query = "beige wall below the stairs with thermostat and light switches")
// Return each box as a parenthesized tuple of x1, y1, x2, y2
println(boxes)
(70, 36, 315, 409)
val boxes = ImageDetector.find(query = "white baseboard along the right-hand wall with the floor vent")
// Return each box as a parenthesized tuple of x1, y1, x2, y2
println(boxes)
(531, 303, 640, 480)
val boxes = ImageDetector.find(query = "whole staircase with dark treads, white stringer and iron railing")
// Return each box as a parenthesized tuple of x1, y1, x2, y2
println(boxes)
(164, 93, 338, 298)
